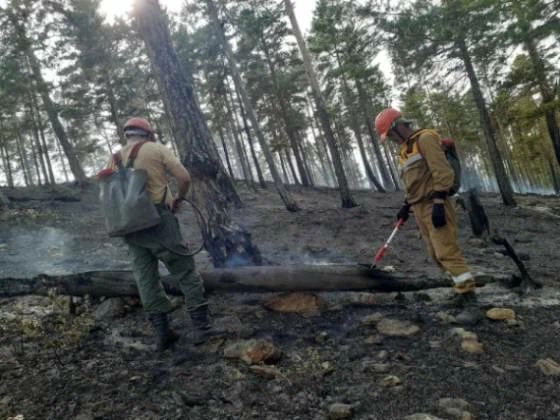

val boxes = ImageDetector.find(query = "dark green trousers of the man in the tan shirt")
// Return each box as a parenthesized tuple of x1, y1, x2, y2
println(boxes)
(124, 206, 207, 313)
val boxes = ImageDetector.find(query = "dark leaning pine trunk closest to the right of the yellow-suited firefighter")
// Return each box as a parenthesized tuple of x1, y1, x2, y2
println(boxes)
(458, 40, 516, 206)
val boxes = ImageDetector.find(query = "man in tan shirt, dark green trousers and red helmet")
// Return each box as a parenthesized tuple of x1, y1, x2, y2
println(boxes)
(108, 118, 217, 351)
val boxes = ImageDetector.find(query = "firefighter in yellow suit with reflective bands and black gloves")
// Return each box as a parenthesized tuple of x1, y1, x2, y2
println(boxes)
(375, 108, 482, 324)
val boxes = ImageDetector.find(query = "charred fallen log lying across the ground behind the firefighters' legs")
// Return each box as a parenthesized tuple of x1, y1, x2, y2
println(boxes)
(0, 265, 509, 297)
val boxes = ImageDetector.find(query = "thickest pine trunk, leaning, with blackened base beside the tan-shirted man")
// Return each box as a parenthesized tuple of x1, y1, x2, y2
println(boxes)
(133, 0, 262, 267)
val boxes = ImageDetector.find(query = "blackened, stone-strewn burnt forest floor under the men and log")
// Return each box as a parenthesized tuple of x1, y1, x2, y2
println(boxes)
(0, 181, 560, 420)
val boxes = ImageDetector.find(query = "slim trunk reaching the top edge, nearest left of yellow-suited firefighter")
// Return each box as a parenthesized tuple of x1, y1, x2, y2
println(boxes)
(284, 0, 357, 208)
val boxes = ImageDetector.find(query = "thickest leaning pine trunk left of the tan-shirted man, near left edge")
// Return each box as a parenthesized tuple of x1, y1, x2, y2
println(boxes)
(20, 48, 87, 183)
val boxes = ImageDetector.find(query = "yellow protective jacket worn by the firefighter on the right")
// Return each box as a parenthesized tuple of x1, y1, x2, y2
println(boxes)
(400, 130, 455, 204)
